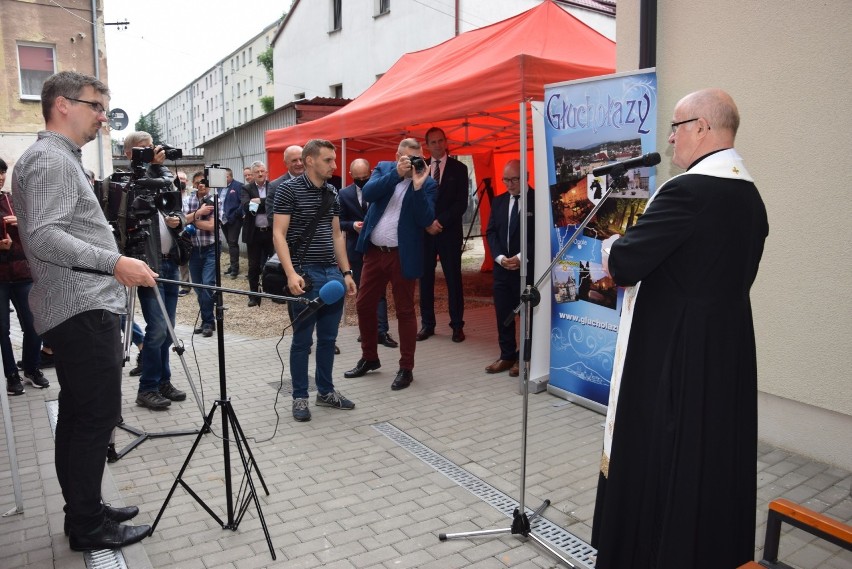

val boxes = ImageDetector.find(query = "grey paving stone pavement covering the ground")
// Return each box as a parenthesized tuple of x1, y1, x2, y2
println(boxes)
(0, 308, 852, 569)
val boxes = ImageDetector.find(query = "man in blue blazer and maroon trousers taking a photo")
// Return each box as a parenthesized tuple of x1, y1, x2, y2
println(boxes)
(343, 138, 437, 390)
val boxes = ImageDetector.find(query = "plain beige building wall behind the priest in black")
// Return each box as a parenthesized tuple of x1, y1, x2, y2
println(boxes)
(617, 0, 852, 470)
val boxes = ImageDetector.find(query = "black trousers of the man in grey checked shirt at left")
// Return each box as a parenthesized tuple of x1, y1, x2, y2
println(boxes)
(43, 310, 122, 535)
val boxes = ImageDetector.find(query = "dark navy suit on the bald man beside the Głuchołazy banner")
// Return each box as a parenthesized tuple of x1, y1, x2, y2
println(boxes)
(485, 188, 535, 361)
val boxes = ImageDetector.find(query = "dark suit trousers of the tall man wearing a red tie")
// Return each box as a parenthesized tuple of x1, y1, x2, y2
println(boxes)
(420, 231, 464, 330)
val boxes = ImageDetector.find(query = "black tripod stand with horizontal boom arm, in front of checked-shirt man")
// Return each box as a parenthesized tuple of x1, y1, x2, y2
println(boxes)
(151, 189, 309, 559)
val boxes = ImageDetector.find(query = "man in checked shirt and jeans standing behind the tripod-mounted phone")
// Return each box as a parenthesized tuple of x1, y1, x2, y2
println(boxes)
(184, 170, 217, 332)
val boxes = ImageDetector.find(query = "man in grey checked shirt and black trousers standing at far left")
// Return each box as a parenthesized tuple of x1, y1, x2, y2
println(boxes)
(12, 71, 151, 551)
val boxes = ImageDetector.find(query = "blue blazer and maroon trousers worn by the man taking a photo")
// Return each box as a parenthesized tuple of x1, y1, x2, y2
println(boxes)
(356, 162, 437, 371)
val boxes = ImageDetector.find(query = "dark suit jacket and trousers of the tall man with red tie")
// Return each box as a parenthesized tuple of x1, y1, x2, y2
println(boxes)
(420, 156, 468, 330)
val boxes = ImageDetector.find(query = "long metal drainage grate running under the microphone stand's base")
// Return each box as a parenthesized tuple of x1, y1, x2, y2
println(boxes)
(373, 423, 597, 569)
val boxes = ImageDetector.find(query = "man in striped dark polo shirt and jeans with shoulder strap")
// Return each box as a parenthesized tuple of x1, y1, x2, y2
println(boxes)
(272, 140, 357, 421)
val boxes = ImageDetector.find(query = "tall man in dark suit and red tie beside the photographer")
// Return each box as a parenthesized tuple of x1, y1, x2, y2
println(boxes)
(417, 127, 468, 342)
